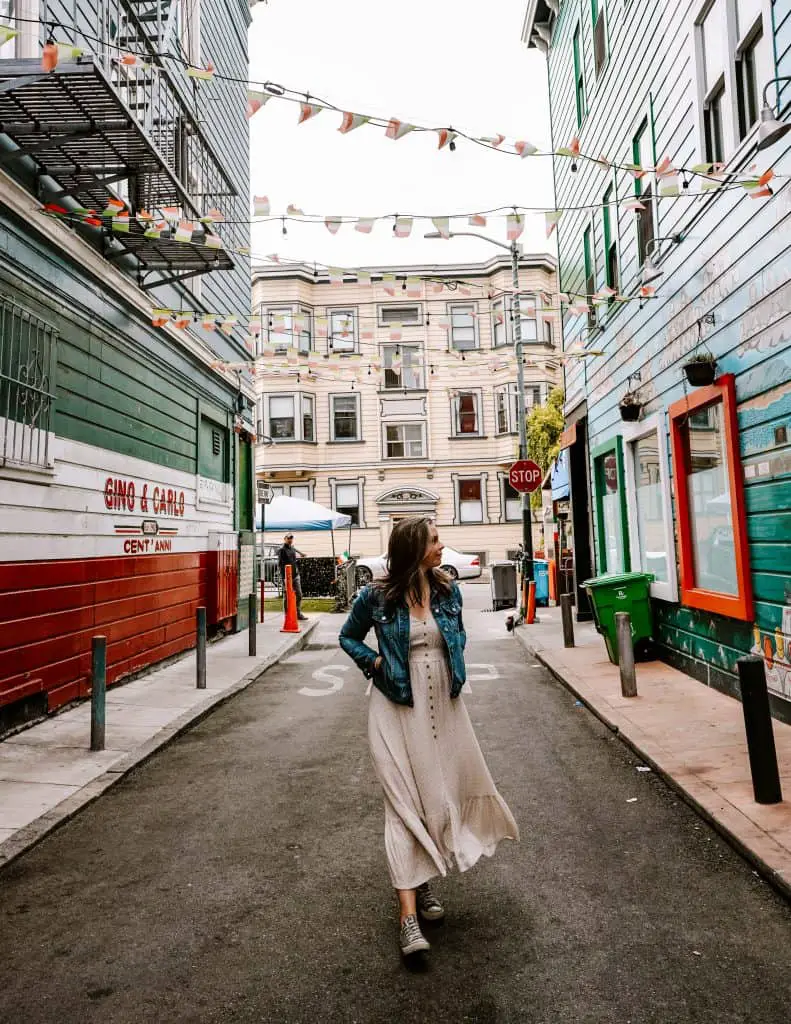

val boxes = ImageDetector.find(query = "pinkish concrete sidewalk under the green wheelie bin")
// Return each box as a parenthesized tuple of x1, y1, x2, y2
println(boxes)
(516, 608, 791, 898)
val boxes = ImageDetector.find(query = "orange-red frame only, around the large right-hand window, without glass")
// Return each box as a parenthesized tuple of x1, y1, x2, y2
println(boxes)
(667, 374, 754, 622)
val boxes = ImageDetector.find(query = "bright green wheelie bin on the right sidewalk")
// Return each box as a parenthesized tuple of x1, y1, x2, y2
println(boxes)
(582, 572, 654, 665)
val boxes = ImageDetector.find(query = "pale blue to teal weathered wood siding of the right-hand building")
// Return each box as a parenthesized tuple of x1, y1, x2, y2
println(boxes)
(548, 0, 791, 714)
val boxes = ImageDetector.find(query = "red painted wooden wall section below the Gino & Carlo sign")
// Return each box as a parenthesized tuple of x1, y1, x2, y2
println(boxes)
(0, 551, 216, 711)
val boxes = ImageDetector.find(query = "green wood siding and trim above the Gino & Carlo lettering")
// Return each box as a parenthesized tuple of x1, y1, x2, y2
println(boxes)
(0, 217, 236, 479)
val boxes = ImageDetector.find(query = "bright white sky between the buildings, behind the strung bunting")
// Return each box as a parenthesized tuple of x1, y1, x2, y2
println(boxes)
(250, 0, 554, 267)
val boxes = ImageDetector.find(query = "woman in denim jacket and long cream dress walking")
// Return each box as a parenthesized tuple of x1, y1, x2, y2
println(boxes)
(340, 516, 518, 955)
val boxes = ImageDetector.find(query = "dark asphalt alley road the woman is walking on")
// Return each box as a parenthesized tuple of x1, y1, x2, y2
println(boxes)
(0, 585, 791, 1024)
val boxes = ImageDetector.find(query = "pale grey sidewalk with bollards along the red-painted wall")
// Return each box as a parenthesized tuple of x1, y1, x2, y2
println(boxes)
(0, 614, 322, 867)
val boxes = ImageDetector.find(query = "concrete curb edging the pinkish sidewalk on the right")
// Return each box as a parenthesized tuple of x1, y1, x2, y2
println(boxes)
(513, 627, 791, 901)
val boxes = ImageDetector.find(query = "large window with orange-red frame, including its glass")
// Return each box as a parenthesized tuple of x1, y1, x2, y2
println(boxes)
(668, 374, 753, 622)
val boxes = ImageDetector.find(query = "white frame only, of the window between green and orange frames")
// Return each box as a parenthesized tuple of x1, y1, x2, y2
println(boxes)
(621, 413, 678, 602)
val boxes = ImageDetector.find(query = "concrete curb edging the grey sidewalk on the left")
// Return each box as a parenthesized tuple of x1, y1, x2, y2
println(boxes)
(0, 618, 321, 871)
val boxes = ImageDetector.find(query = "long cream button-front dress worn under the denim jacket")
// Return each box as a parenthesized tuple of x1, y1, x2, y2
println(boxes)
(368, 614, 519, 889)
